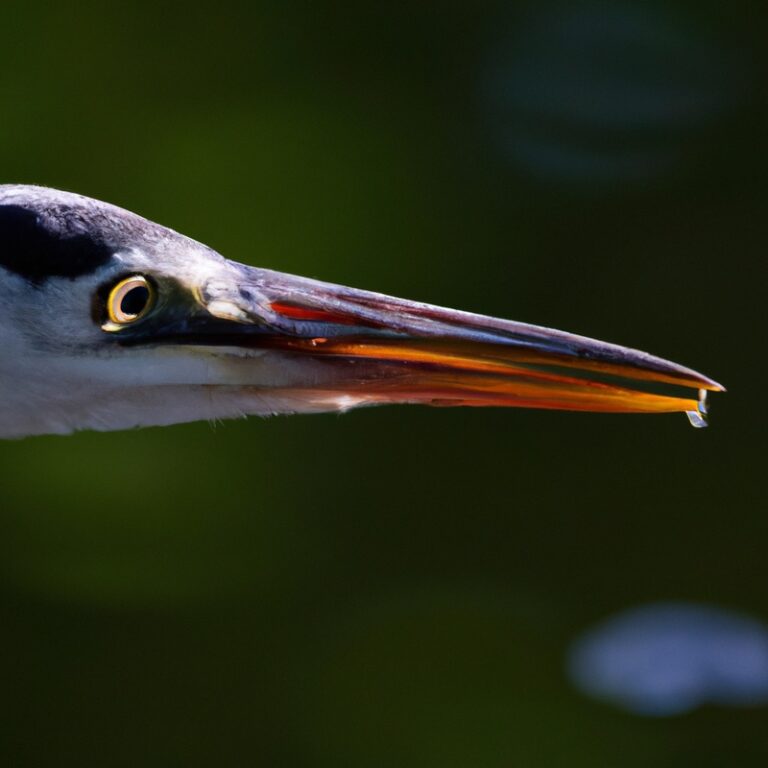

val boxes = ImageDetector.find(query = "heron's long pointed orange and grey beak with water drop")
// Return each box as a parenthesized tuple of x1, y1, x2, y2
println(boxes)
(152, 262, 724, 426)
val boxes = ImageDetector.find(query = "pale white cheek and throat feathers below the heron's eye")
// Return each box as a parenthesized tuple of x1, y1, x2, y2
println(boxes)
(0, 332, 365, 438)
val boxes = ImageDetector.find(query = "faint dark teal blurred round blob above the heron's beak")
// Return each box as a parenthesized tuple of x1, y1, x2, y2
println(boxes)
(483, 2, 746, 183)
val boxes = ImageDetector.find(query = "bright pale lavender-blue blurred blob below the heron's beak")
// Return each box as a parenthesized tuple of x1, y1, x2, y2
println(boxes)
(568, 603, 768, 716)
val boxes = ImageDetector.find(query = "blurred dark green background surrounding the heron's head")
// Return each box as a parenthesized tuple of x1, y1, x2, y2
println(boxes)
(0, 0, 768, 768)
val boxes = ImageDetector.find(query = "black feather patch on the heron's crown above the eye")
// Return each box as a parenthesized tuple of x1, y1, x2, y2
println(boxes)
(0, 205, 112, 285)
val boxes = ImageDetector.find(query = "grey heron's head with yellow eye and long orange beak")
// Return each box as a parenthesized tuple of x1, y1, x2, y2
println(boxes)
(0, 185, 722, 437)
